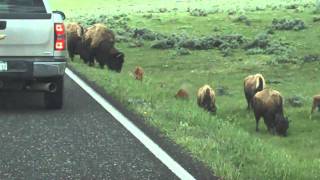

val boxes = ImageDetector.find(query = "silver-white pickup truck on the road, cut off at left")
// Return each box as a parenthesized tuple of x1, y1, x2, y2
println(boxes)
(0, 0, 66, 109)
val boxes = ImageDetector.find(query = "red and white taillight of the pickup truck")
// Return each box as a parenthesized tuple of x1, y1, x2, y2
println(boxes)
(54, 23, 66, 51)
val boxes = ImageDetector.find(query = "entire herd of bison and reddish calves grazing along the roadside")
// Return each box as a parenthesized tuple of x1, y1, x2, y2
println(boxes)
(66, 23, 320, 136)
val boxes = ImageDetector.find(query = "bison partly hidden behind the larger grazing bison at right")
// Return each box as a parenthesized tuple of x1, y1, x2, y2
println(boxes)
(244, 74, 266, 110)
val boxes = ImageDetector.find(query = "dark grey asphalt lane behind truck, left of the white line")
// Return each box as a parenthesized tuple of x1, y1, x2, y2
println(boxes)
(0, 78, 177, 180)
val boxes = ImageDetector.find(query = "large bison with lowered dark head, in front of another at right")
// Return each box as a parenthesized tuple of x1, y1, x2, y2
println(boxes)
(252, 89, 289, 136)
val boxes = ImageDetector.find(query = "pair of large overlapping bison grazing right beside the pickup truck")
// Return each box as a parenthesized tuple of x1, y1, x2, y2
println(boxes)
(66, 23, 124, 72)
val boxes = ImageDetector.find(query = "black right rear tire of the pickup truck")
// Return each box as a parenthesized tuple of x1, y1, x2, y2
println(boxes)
(44, 77, 63, 109)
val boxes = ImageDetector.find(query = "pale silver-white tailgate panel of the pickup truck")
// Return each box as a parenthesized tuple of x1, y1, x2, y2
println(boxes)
(0, 19, 54, 56)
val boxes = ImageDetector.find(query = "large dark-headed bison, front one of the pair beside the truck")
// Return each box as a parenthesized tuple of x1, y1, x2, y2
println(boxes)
(80, 24, 124, 72)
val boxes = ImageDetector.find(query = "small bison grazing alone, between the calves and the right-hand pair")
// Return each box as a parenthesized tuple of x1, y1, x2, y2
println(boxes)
(197, 85, 217, 113)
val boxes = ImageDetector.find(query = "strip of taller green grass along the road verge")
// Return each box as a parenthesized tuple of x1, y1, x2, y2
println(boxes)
(72, 63, 320, 180)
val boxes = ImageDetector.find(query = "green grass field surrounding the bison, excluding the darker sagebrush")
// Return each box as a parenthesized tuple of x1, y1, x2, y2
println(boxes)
(51, 0, 320, 179)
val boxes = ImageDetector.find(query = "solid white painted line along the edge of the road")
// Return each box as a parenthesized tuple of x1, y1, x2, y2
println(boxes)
(65, 68, 195, 180)
